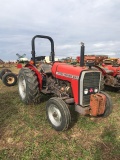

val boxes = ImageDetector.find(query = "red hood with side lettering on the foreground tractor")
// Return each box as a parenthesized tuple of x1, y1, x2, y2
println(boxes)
(52, 62, 88, 80)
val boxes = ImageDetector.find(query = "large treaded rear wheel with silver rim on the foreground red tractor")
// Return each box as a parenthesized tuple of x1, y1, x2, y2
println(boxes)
(18, 68, 40, 104)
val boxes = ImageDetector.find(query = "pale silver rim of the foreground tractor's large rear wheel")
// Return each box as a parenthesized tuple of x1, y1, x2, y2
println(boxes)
(18, 76, 26, 99)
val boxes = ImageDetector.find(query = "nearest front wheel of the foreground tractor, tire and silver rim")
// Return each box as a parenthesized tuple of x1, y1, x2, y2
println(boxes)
(46, 97, 71, 131)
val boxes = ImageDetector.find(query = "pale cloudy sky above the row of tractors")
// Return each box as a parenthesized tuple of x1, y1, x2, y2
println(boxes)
(0, 0, 120, 61)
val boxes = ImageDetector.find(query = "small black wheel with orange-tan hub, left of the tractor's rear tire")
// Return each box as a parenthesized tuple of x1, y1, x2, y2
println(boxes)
(2, 72, 17, 87)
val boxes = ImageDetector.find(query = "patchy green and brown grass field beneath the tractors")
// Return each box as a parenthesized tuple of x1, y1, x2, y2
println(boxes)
(0, 67, 120, 160)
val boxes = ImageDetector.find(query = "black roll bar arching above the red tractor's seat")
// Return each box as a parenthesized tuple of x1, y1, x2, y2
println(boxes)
(31, 35, 55, 65)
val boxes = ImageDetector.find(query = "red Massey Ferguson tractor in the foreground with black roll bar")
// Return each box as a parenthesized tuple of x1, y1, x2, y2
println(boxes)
(18, 35, 112, 131)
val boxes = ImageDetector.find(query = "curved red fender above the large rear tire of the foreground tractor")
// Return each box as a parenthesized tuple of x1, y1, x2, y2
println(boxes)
(25, 64, 42, 90)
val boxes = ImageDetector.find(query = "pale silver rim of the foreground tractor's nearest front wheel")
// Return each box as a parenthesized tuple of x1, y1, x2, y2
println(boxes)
(48, 104, 62, 126)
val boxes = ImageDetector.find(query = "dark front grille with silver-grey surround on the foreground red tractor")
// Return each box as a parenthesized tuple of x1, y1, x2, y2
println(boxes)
(80, 71, 100, 106)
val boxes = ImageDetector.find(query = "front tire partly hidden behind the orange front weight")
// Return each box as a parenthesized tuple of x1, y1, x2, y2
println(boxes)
(101, 91, 113, 117)
